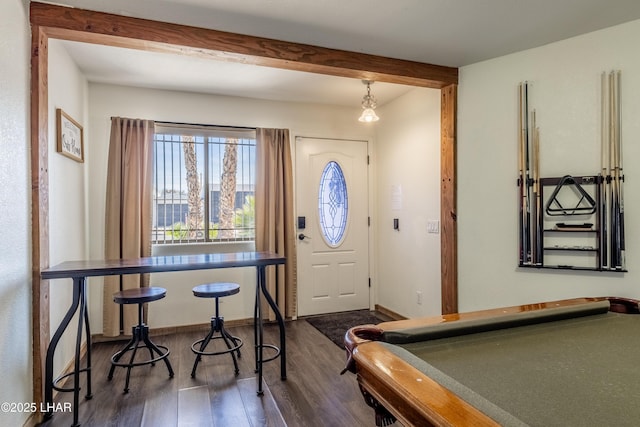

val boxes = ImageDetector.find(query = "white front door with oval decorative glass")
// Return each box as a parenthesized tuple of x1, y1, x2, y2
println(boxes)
(296, 137, 369, 316)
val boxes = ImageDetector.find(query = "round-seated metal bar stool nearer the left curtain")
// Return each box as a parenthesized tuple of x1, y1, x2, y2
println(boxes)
(107, 287, 173, 393)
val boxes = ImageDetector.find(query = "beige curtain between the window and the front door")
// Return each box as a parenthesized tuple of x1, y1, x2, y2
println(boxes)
(255, 129, 298, 320)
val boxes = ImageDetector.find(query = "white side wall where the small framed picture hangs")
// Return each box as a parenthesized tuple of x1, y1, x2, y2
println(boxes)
(49, 39, 92, 388)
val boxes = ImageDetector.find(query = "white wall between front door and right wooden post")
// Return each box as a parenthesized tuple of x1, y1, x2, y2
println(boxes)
(374, 88, 441, 317)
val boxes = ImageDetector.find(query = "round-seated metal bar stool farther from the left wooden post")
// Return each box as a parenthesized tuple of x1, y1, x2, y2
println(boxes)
(191, 283, 242, 378)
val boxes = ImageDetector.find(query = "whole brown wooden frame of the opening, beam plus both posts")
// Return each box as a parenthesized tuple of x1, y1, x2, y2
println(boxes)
(29, 2, 458, 416)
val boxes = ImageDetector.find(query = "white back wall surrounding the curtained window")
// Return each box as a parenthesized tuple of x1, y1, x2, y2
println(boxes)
(84, 84, 375, 332)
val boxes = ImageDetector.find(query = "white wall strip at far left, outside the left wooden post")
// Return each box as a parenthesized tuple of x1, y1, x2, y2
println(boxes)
(0, 0, 33, 426)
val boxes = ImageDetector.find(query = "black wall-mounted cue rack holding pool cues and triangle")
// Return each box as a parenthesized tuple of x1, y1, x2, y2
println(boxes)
(518, 71, 627, 272)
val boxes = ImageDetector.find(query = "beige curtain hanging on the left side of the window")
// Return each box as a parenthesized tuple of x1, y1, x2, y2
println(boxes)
(103, 117, 154, 337)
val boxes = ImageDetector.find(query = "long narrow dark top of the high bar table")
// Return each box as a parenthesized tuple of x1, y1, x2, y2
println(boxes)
(40, 252, 286, 280)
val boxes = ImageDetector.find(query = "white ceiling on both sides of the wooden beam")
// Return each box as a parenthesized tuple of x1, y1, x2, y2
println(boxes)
(55, 0, 640, 105)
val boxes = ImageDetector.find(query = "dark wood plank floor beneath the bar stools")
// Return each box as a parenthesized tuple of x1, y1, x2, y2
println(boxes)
(43, 320, 375, 427)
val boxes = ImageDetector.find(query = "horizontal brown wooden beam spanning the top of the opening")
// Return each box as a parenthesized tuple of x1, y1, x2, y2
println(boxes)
(31, 2, 458, 89)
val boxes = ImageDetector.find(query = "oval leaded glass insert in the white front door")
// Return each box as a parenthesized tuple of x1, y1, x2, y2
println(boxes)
(318, 161, 349, 247)
